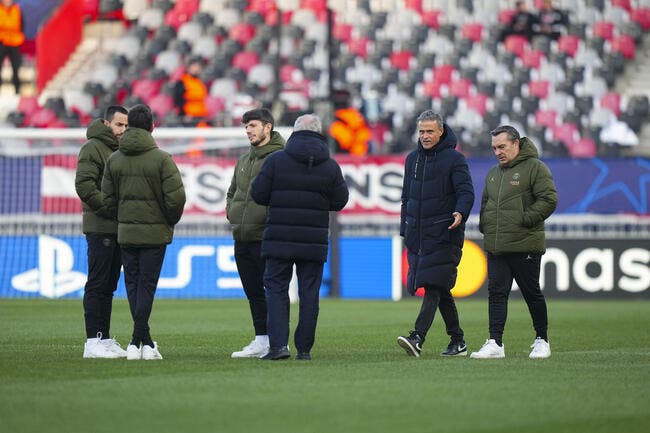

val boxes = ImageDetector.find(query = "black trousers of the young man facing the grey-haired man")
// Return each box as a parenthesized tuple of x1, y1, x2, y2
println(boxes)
(235, 241, 267, 335)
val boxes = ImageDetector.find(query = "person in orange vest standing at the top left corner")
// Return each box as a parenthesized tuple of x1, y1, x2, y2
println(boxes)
(0, 0, 25, 95)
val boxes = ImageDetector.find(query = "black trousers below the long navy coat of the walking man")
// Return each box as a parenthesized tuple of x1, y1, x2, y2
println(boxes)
(415, 287, 464, 342)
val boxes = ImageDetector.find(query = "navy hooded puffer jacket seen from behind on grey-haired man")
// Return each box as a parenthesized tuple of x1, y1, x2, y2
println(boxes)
(251, 131, 348, 262)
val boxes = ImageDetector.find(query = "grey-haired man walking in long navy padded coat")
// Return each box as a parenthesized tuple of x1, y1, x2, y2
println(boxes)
(397, 110, 474, 357)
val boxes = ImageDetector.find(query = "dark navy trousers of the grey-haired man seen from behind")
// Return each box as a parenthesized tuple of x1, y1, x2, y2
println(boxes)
(264, 257, 323, 353)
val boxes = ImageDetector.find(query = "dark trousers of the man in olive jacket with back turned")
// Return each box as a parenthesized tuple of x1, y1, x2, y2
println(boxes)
(122, 245, 167, 346)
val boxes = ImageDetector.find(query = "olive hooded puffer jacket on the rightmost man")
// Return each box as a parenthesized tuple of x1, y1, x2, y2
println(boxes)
(479, 137, 557, 254)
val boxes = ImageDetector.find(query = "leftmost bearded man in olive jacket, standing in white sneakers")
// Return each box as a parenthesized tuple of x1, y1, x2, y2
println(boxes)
(75, 105, 129, 358)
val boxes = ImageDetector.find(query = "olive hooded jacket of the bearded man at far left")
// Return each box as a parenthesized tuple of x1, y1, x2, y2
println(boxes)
(74, 119, 118, 234)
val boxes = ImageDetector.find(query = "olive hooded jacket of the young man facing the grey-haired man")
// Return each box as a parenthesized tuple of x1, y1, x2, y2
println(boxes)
(226, 131, 284, 242)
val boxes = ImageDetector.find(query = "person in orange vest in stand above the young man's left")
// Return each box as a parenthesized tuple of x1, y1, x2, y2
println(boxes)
(174, 56, 208, 126)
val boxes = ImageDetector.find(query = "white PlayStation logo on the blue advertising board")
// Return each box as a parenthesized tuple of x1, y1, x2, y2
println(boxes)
(11, 235, 86, 298)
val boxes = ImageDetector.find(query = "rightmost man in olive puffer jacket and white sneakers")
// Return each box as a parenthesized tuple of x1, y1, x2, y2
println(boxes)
(471, 126, 558, 359)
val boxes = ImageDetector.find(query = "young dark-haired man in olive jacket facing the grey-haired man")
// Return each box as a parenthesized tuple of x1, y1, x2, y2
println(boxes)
(226, 108, 284, 358)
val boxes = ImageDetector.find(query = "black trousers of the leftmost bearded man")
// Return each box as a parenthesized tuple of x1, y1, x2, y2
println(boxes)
(83, 233, 122, 338)
